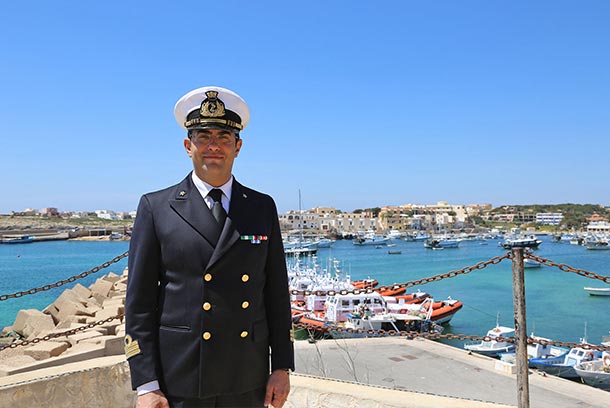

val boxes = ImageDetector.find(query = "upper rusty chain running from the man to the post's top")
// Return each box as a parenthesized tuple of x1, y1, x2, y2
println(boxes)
(290, 252, 511, 296)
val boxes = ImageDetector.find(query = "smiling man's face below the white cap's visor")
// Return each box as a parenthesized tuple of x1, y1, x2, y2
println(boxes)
(184, 129, 242, 187)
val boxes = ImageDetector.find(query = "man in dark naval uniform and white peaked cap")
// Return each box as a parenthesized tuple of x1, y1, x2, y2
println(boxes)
(125, 87, 294, 408)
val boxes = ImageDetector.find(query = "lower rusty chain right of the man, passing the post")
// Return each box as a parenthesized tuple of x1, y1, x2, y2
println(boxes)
(294, 323, 610, 351)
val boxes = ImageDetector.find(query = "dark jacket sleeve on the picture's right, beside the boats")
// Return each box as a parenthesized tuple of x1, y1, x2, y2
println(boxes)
(265, 199, 294, 370)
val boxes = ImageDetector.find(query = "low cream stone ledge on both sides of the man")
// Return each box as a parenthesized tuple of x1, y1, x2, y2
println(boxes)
(0, 356, 509, 408)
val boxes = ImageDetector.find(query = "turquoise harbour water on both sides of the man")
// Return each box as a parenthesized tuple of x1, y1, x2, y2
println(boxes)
(0, 237, 610, 345)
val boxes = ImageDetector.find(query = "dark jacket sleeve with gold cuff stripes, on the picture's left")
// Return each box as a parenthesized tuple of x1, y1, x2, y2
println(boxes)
(125, 196, 161, 390)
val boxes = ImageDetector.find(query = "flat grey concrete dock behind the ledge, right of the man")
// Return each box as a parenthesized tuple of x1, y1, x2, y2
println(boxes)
(295, 337, 610, 408)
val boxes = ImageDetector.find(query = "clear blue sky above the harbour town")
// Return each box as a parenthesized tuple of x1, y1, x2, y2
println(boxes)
(0, 0, 610, 213)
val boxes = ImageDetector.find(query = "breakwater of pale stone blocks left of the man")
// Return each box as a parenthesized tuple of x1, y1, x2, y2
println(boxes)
(0, 270, 127, 377)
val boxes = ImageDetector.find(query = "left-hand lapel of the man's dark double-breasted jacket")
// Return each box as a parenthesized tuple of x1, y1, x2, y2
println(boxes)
(169, 173, 221, 247)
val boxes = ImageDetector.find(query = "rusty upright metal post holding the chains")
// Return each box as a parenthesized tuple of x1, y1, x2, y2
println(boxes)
(512, 248, 530, 408)
